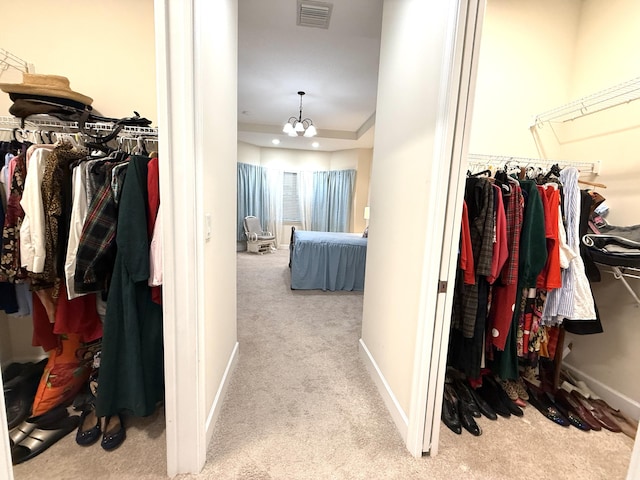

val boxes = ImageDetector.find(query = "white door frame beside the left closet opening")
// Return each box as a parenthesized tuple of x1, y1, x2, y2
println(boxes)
(154, 0, 207, 477)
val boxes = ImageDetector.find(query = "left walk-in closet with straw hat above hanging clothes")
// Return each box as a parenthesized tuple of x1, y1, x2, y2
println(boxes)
(0, 1, 175, 479)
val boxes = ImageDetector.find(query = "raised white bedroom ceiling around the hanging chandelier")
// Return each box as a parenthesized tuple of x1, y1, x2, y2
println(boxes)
(238, 0, 382, 151)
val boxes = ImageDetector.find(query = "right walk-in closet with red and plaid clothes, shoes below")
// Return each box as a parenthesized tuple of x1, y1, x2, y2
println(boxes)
(441, 0, 640, 478)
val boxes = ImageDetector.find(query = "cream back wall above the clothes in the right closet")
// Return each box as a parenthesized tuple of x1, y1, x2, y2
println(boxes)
(469, 0, 582, 158)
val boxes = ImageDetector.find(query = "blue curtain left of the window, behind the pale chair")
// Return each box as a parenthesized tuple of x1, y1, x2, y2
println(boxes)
(237, 163, 269, 242)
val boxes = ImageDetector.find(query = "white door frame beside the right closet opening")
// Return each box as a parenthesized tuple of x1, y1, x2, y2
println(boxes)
(407, 0, 485, 456)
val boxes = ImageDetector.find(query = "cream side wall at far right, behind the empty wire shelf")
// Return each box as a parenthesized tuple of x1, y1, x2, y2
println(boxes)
(556, 0, 640, 408)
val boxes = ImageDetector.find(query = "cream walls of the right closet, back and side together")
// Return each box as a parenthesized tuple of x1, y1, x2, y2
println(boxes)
(470, 0, 640, 414)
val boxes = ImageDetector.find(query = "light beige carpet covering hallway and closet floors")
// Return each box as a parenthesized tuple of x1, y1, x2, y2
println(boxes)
(14, 250, 633, 480)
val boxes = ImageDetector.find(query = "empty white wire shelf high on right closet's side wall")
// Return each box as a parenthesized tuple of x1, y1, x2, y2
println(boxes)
(531, 77, 640, 128)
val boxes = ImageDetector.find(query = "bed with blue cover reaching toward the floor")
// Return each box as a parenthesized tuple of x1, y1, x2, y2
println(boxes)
(289, 227, 367, 291)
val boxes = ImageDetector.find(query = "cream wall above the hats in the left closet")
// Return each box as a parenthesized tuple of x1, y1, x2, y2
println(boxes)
(0, 0, 157, 123)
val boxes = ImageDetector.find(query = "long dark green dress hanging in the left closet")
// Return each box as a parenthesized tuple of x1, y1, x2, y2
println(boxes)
(97, 156, 164, 416)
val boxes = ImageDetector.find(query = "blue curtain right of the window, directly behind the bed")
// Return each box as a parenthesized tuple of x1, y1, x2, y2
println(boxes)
(311, 170, 356, 232)
